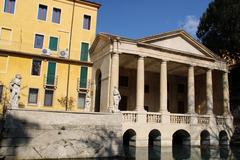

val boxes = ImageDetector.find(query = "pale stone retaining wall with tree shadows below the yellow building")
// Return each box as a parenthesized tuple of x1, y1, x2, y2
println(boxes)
(0, 110, 122, 159)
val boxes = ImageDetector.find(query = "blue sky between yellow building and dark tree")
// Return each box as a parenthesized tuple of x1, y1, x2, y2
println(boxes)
(93, 0, 212, 38)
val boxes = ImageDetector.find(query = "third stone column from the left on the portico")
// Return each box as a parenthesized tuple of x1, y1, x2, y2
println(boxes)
(159, 61, 168, 112)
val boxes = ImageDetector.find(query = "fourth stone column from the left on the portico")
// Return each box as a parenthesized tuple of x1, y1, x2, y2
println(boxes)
(188, 65, 195, 114)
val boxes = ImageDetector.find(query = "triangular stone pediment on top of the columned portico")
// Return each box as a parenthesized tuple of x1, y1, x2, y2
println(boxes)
(139, 30, 216, 59)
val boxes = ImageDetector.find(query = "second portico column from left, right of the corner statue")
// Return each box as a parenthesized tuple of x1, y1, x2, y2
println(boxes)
(136, 56, 145, 111)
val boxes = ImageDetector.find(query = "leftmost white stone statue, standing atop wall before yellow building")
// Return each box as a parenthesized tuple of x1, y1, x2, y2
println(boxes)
(9, 74, 22, 109)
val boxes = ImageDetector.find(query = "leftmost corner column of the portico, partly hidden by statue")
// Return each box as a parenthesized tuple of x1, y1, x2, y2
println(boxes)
(109, 53, 119, 111)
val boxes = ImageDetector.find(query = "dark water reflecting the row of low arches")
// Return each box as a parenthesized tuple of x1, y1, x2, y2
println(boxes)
(123, 145, 240, 160)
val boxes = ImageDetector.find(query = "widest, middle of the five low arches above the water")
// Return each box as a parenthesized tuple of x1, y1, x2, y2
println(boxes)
(172, 129, 191, 145)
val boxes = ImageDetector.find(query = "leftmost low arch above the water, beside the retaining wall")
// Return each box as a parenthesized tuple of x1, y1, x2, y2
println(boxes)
(123, 129, 136, 146)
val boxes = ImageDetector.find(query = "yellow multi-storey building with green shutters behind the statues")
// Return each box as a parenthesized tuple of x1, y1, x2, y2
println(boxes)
(0, 0, 100, 111)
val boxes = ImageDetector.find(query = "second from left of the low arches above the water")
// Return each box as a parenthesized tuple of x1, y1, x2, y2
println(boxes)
(148, 129, 161, 146)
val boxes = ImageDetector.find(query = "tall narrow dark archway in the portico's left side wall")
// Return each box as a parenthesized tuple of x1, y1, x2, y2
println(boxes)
(94, 69, 102, 112)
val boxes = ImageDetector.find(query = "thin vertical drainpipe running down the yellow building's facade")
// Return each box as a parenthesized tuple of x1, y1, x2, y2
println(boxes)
(65, 0, 76, 111)
